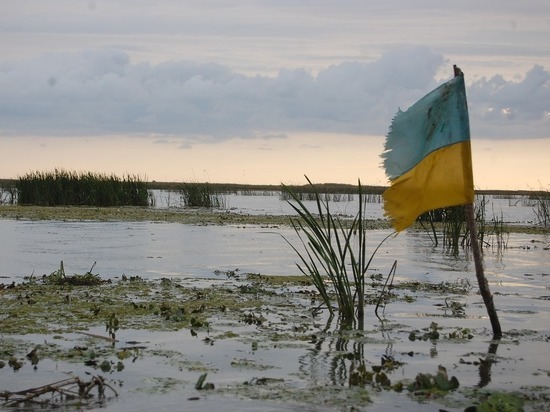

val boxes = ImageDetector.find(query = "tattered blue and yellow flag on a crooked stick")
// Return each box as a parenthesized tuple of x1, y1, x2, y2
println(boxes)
(382, 75, 474, 231)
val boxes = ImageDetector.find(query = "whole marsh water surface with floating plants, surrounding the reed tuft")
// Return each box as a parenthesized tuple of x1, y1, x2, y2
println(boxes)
(0, 193, 550, 411)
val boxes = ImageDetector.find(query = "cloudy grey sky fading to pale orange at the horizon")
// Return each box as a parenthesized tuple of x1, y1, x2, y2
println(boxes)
(0, 0, 550, 190)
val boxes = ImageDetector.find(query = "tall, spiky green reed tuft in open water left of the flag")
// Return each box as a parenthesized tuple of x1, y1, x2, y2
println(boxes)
(283, 176, 391, 328)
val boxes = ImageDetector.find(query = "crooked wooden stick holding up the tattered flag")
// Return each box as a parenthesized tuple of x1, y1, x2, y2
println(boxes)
(453, 64, 502, 339)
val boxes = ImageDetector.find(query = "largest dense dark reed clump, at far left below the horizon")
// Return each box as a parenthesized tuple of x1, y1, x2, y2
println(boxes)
(15, 169, 149, 207)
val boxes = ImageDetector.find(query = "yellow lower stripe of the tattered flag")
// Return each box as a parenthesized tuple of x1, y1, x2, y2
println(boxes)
(384, 140, 474, 231)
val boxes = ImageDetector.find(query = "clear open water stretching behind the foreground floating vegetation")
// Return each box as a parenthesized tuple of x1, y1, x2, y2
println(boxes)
(0, 194, 550, 330)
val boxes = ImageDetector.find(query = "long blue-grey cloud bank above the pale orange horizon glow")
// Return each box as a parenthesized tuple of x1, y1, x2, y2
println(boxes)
(0, 47, 550, 142)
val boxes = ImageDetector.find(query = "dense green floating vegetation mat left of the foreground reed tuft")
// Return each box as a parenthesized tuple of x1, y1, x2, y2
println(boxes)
(0, 263, 268, 337)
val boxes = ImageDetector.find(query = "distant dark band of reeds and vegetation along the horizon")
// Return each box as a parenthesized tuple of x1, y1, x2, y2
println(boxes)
(0, 169, 550, 233)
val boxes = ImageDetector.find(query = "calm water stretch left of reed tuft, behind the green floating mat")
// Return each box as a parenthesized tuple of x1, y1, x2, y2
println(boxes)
(0, 220, 300, 282)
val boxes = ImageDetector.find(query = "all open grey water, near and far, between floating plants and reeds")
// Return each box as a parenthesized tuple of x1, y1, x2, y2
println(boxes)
(0, 195, 550, 412)
